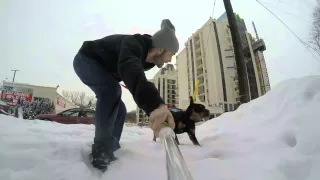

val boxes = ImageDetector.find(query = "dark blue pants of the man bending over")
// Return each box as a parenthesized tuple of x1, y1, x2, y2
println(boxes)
(73, 53, 127, 151)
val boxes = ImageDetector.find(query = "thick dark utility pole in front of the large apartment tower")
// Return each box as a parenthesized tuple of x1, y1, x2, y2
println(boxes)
(223, 0, 250, 103)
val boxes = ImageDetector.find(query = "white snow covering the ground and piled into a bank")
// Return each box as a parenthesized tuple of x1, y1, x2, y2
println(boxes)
(0, 76, 320, 180)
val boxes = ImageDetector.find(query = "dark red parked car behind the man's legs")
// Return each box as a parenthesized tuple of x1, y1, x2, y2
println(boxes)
(34, 108, 95, 124)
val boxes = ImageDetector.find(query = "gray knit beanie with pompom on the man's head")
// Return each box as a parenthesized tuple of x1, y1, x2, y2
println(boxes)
(152, 19, 179, 53)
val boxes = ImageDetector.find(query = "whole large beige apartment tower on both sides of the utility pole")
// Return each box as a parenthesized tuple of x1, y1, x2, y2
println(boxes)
(177, 14, 270, 117)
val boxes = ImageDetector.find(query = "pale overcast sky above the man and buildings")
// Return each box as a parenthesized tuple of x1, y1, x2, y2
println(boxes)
(0, 0, 320, 110)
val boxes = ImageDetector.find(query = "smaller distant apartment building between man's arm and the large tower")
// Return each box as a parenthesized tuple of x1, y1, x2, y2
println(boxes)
(136, 64, 179, 122)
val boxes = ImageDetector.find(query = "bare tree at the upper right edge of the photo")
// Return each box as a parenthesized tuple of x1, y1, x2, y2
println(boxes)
(310, 0, 320, 55)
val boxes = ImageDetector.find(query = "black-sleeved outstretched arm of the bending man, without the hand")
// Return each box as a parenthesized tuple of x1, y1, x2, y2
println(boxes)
(118, 36, 164, 115)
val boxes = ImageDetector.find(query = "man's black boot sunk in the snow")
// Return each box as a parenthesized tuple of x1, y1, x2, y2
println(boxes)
(91, 143, 117, 171)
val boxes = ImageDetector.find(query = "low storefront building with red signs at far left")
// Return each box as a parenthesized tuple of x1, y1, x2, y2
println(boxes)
(1, 81, 78, 113)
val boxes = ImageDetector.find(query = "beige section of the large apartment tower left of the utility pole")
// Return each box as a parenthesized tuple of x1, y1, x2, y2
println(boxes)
(177, 18, 239, 117)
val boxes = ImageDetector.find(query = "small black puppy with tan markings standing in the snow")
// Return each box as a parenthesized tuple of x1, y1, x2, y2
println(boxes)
(153, 96, 210, 146)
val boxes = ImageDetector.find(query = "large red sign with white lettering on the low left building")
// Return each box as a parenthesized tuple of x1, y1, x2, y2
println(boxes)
(2, 90, 32, 106)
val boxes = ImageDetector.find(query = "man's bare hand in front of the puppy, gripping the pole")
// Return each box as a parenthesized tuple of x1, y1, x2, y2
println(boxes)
(149, 104, 175, 137)
